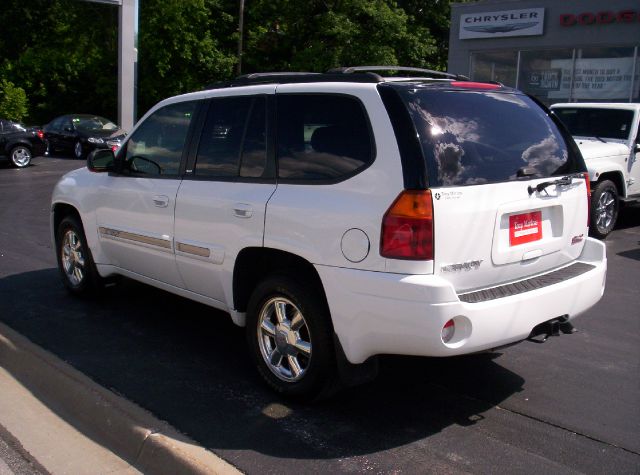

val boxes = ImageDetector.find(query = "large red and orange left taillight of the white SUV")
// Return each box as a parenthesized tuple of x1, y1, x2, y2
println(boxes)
(380, 190, 433, 260)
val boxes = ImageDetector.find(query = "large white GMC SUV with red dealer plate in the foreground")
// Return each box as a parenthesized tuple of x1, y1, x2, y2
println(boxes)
(51, 67, 606, 397)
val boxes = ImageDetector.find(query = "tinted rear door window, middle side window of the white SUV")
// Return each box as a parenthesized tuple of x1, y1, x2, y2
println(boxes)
(194, 96, 266, 177)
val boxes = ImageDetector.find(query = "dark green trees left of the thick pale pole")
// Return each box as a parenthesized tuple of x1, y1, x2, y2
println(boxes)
(0, 0, 118, 123)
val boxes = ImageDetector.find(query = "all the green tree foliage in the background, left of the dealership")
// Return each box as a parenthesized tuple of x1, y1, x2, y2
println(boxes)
(0, 0, 460, 124)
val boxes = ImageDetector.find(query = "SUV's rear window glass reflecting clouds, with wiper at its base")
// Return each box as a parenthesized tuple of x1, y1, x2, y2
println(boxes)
(397, 86, 580, 186)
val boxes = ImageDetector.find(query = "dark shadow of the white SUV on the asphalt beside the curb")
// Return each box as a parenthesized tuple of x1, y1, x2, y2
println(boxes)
(0, 269, 524, 470)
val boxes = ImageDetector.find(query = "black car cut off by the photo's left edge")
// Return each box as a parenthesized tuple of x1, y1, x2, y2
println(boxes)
(0, 119, 45, 168)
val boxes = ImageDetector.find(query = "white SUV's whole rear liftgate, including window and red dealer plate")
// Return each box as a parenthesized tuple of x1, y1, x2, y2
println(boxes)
(388, 86, 588, 293)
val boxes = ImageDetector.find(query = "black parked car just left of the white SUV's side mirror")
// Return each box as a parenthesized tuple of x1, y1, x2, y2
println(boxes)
(44, 114, 126, 159)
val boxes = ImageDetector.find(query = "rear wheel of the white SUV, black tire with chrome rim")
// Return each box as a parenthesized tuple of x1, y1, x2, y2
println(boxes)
(246, 274, 337, 400)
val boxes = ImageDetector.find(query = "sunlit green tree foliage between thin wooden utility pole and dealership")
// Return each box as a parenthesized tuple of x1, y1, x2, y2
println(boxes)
(245, 0, 436, 71)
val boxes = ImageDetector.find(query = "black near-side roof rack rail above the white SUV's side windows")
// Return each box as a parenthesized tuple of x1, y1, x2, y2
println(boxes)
(204, 72, 384, 89)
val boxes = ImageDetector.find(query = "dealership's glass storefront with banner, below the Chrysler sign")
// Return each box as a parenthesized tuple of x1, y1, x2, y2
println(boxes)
(471, 47, 640, 105)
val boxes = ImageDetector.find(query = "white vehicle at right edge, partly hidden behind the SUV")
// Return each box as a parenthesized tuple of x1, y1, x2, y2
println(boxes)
(551, 103, 640, 239)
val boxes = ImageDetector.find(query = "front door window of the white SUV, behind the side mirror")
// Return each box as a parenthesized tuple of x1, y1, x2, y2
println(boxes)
(123, 101, 196, 176)
